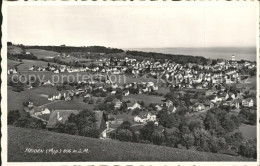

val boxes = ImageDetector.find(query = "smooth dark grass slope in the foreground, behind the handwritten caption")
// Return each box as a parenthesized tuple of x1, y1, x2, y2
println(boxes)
(8, 126, 254, 162)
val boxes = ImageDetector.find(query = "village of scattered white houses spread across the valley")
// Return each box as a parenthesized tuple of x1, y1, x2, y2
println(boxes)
(8, 48, 256, 138)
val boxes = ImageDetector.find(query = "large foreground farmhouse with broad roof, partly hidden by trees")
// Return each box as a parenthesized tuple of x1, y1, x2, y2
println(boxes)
(46, 110, 107, 137)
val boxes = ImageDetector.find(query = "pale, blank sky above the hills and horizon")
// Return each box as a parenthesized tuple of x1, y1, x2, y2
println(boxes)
(7, 3, 258, 48)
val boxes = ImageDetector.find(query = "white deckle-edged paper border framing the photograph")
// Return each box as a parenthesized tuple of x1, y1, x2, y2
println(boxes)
(1, 1, 260, 166)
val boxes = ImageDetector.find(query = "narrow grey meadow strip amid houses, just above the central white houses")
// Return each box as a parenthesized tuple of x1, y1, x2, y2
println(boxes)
(124, 94, 164, 105)
